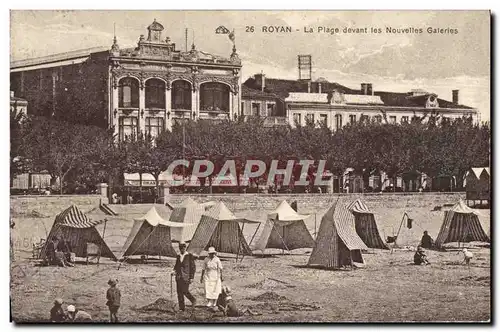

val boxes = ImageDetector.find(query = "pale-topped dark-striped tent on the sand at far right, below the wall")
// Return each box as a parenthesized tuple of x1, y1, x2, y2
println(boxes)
(435, 200, 490, 248)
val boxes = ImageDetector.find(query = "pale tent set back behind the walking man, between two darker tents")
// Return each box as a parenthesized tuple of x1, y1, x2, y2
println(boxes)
(169, 197, 208, 242)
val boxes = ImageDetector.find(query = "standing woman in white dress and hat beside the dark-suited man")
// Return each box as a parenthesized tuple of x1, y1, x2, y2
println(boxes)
(200, 247, 222, 308)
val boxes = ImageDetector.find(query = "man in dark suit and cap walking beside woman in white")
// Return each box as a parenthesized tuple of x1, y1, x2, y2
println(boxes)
(172, 242, 196, 311)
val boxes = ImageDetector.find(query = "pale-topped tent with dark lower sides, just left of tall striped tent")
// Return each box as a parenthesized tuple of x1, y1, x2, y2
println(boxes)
(252, 201, 314, 251)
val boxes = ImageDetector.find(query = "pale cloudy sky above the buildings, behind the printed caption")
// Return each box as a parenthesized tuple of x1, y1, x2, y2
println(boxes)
(11, 11, 490, 121)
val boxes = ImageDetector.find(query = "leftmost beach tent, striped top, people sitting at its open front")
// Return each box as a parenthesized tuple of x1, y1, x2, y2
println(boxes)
(40, 205, 116, 260)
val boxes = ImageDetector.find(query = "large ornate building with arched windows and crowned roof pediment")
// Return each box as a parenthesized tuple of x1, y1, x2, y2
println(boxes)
(11, 20, 241, 139)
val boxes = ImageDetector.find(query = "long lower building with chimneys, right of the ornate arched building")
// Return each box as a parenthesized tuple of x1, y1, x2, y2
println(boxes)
(242, 73, 478, 130)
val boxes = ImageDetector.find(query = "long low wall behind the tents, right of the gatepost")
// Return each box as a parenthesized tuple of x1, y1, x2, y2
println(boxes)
(162, 193, 465, 213)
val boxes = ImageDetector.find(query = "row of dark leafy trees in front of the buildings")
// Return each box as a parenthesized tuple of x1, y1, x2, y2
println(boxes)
(11, 110, 490, 192)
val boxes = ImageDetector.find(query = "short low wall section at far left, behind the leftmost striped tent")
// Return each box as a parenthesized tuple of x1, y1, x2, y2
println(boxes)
(10, 195, 102, 217)
